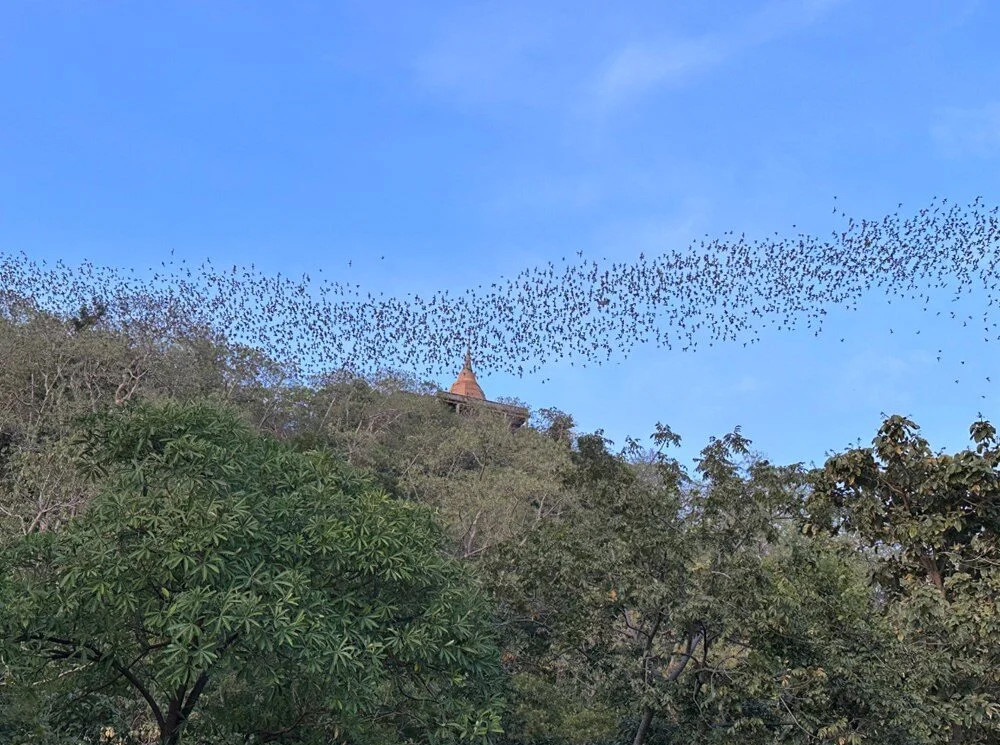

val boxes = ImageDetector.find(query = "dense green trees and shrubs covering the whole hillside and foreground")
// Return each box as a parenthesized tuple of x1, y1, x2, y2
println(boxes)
(0, 302, 1000, 745)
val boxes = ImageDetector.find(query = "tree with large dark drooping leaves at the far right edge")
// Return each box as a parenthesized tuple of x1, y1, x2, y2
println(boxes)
(808, 416, 1000, 745)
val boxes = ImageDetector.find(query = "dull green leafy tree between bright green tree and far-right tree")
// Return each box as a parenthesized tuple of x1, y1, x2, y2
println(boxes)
(497, 428, 921, 745)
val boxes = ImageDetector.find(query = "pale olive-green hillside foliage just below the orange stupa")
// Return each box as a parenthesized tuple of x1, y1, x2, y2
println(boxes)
(282, 377, 572, 558)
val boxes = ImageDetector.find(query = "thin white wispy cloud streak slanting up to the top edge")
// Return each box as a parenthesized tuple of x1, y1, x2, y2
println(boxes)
(593, 0, 843, 108)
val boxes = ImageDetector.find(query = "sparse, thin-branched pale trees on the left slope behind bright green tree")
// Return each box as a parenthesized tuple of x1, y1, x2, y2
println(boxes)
(0, 298, 287, 543)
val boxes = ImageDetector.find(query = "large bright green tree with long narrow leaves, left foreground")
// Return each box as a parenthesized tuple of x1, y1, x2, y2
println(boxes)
(0, 404, 497, 745)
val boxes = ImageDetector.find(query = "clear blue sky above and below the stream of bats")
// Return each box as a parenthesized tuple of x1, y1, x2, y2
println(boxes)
(0, 0, 1000, 462)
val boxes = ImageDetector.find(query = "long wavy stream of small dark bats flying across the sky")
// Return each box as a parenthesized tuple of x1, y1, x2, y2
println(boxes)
(0, 199, 1000, 390)
